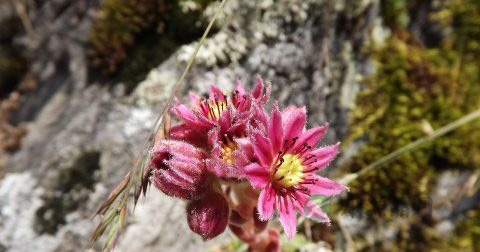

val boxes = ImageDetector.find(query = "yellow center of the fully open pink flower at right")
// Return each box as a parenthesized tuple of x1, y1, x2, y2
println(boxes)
(273, 154, 305, 188)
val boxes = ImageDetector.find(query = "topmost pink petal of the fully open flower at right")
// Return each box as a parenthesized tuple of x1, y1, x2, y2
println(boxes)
(282, 107, 307, 140)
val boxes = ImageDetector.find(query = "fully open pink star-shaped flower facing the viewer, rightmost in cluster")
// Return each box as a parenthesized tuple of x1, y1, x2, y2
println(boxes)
(245, 105, 346, 238)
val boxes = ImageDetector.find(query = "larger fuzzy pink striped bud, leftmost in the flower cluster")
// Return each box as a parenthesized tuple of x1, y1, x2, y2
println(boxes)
(150, 140, 206, 199)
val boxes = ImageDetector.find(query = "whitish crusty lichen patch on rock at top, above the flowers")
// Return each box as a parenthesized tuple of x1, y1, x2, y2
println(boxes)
(178, 0, 323, 66)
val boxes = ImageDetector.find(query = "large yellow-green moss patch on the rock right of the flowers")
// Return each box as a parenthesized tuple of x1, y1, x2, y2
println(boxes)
(342, 0, 480, 219)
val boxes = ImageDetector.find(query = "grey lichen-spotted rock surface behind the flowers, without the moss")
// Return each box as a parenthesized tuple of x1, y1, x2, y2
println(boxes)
(0, 0, 378, 252)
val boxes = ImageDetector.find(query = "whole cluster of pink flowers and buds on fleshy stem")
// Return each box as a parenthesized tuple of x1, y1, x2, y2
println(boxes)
(150, 78, 346, 251)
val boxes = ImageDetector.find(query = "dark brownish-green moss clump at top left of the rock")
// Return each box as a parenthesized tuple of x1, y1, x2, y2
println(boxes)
(89, 0, 213, 91)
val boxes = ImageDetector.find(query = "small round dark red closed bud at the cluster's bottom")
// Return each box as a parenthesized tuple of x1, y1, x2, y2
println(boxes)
(187, 193, 229, 240)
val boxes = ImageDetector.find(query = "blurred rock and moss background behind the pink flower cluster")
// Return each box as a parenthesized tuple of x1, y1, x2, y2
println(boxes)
(0, 0, 480, 252)
